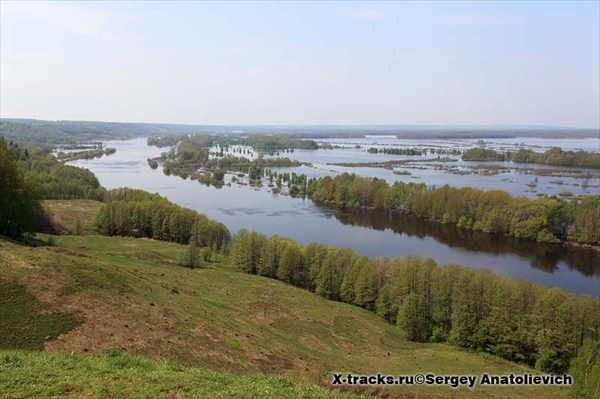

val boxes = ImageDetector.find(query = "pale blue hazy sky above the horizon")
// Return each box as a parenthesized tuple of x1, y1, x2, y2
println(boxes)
(0, 0, 600, 127)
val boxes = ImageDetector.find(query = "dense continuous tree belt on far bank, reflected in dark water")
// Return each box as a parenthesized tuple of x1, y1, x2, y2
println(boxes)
(307, 173, 600, 245)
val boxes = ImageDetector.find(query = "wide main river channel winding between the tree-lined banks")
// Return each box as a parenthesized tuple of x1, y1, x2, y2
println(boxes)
(70, 139, 600, 297)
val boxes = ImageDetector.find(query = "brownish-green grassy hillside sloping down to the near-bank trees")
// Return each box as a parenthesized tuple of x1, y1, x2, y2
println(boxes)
(0, 235, 567, 398)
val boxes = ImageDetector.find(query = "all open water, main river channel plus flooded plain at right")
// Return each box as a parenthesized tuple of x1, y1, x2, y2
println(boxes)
(70, 136, 600, 296)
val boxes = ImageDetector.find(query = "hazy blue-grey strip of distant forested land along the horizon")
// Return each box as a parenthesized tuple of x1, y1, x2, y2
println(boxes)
(0, 118, 600, 144)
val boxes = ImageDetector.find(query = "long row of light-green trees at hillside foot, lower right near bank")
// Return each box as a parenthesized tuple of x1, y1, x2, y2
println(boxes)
(230, 230, 600, 373)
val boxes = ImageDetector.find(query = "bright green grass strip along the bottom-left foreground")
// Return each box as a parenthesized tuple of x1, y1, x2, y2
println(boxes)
(0, 351, 358, 399)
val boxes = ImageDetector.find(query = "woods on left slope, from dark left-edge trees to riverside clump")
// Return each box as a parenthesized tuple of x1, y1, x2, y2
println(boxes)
(0, 139, 230, 251)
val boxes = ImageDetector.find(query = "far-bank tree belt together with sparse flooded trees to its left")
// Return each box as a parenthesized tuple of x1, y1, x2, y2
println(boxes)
(152, 136, 600, 245)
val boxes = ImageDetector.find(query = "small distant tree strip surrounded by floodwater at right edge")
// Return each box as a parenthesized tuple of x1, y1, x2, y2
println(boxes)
(462, 147, 600, 169)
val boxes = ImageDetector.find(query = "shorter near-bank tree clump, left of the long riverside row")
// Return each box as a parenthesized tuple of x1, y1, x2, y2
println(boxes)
(95, 188, 230, 250)
